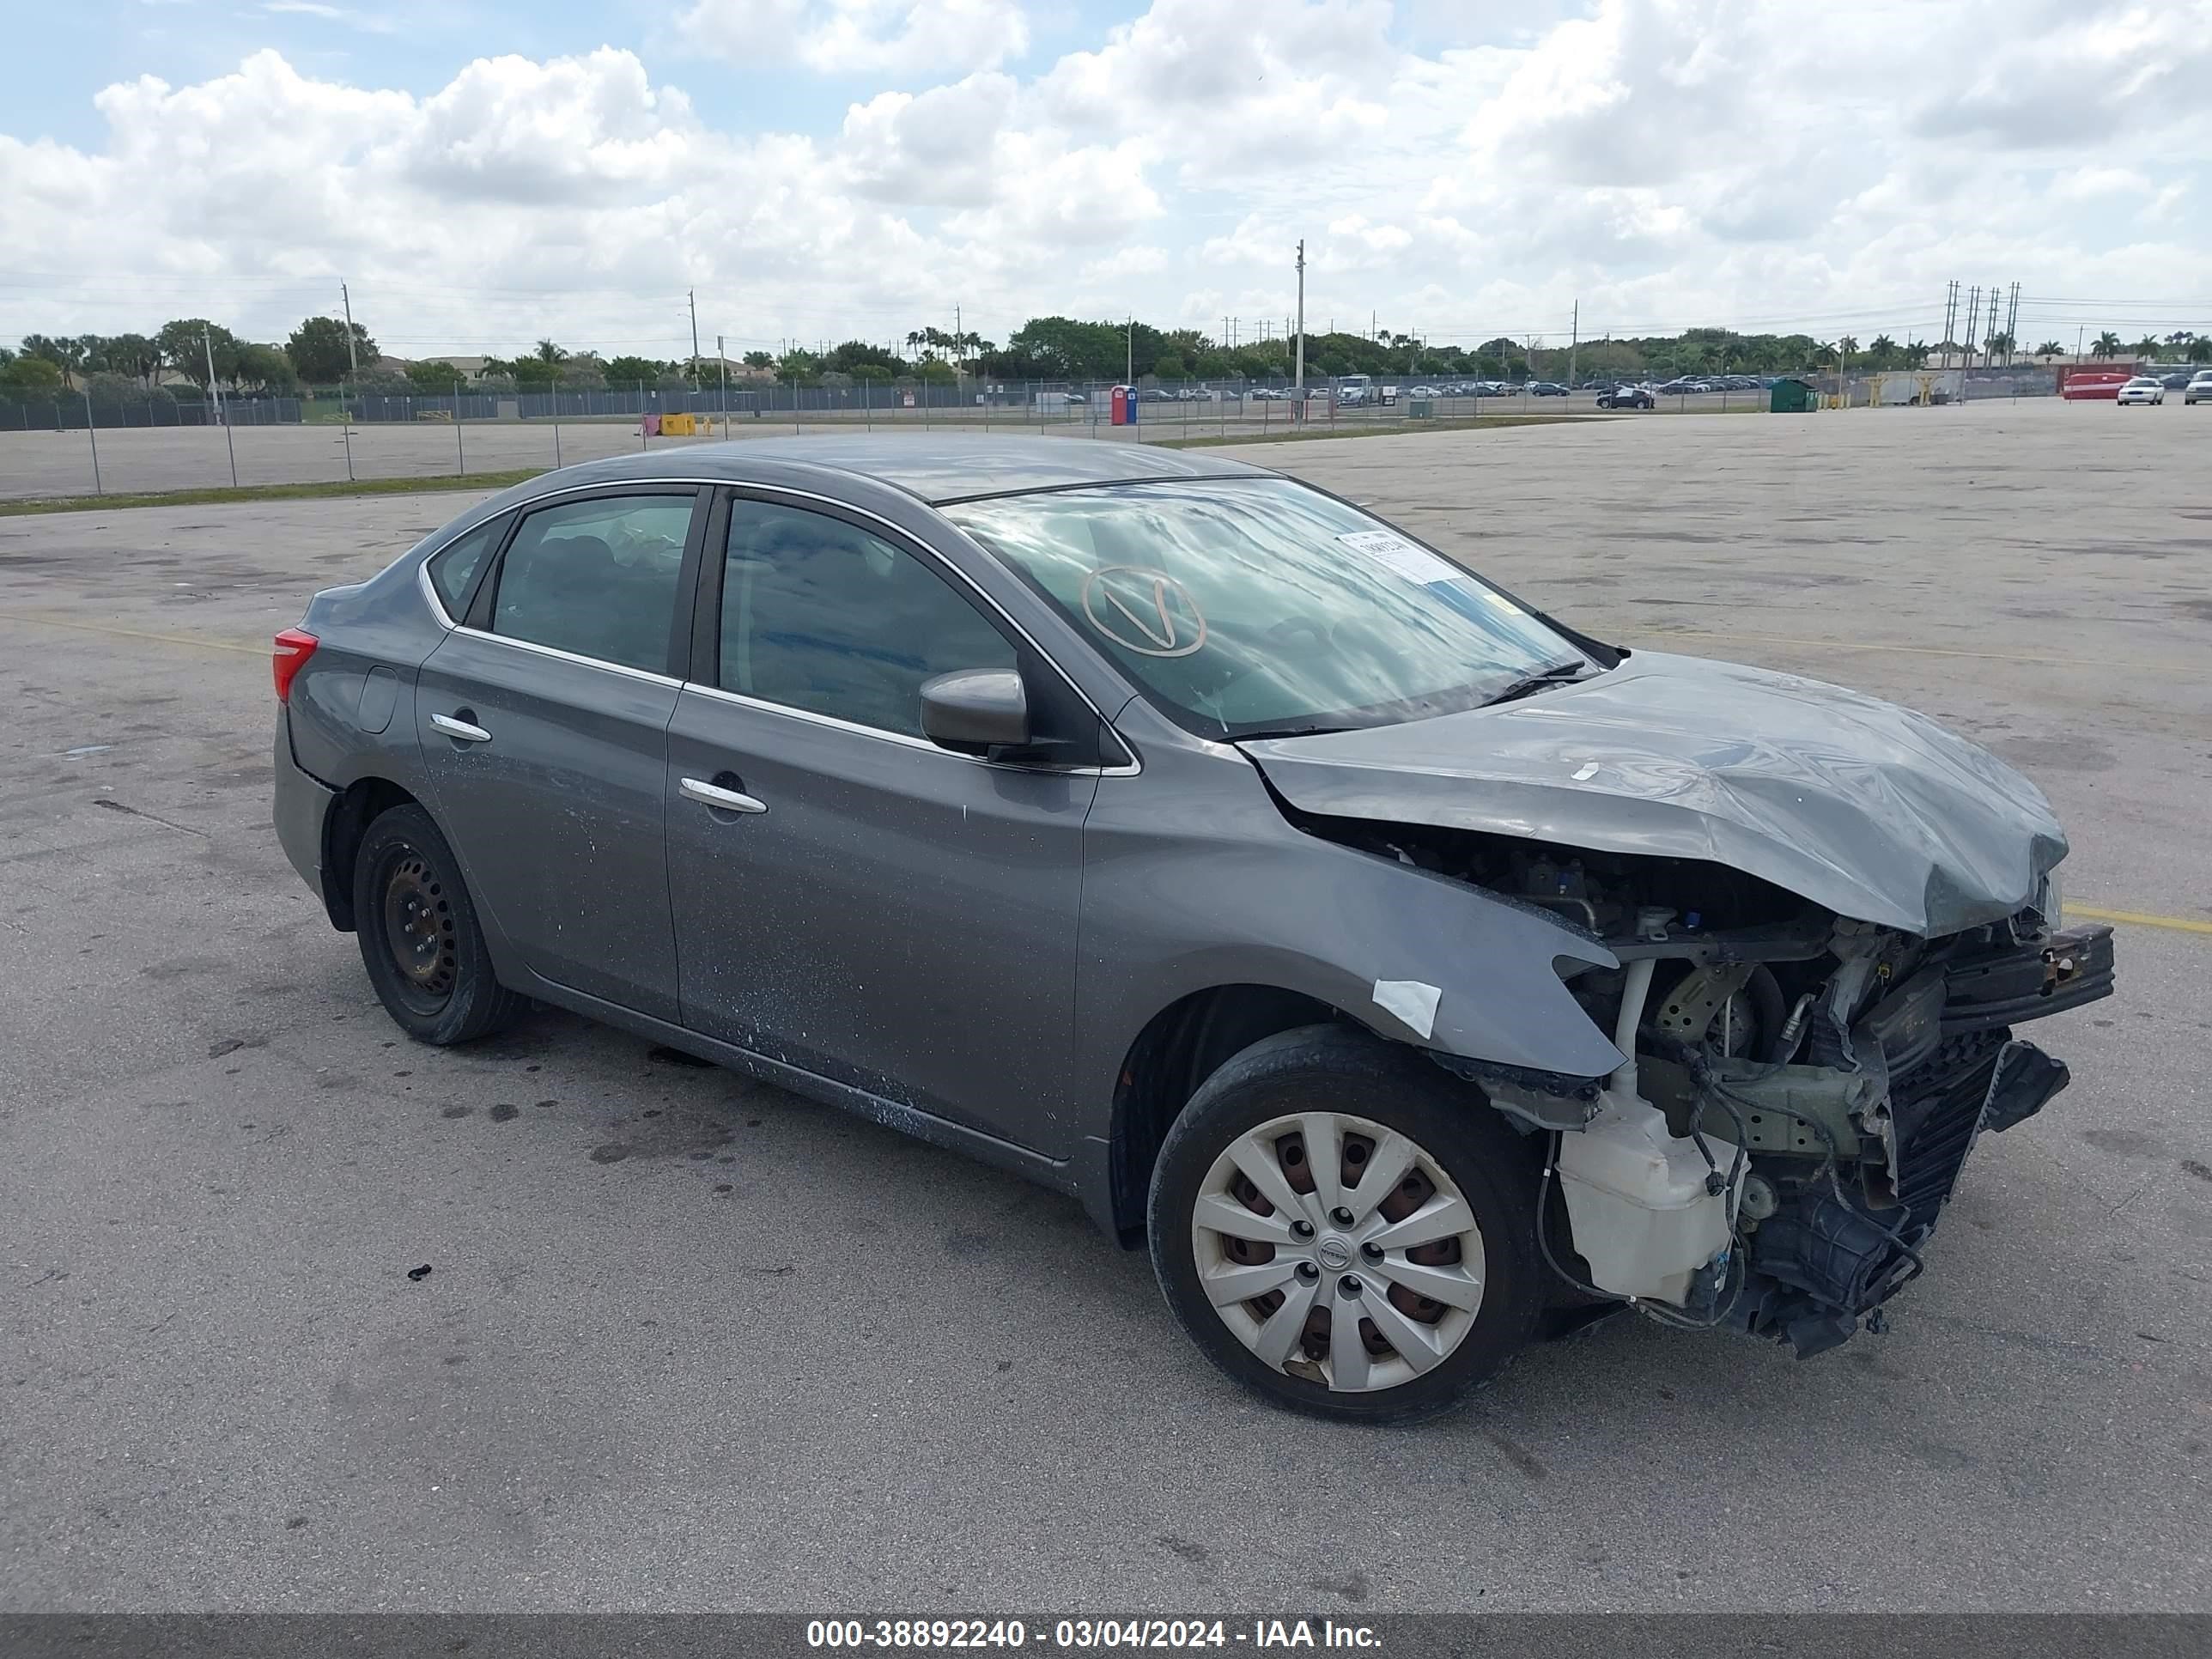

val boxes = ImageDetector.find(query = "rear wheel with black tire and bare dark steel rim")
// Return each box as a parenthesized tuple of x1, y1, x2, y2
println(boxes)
(354, 805, 529, 1048)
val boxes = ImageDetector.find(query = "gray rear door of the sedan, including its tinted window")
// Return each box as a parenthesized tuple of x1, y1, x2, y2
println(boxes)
(416, 484, 702, 1020)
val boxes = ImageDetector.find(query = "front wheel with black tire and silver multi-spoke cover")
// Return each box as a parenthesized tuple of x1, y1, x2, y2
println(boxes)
(1148, 1026, 1544, 1422)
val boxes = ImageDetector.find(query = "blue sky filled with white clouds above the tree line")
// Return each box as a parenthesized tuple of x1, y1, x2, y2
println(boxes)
(0, 0, 2212, 356)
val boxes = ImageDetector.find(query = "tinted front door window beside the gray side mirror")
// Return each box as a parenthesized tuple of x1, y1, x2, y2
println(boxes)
(721, 500, 1015, 737)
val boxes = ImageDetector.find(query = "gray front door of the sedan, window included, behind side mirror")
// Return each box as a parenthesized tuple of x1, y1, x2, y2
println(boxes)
(668, 486, 1099, 1155)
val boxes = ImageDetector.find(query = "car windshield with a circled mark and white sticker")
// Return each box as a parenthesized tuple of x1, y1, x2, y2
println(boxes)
(945, 477, 1589, 738)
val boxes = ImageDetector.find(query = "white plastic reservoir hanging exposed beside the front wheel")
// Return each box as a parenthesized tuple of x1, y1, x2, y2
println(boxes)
(1558, 1088, 1741, 1307)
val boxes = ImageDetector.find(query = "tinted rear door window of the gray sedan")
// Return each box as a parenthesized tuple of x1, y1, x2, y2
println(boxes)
(491, 495, 692, 675)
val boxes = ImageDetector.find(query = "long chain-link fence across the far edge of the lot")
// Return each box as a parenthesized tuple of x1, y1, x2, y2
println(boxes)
(0, 376, 2042, 500)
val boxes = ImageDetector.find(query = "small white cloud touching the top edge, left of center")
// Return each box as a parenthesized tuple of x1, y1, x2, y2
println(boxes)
(679, 0, 1029, 80)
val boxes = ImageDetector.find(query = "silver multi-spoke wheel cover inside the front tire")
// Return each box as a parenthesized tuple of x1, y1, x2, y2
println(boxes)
(1190, 1113, 1486, 1394)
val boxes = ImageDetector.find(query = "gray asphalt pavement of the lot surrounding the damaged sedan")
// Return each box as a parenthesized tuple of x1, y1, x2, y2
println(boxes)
(0, 404, 2212, 1614)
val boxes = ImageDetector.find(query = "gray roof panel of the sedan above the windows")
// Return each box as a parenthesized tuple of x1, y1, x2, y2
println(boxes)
(493, 434, 1274, 507)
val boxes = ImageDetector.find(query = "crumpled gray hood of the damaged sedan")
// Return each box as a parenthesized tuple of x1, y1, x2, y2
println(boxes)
(1241, 650, 2066, 936)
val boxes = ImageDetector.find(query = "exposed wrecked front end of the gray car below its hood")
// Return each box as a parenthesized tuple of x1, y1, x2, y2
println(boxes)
(1307, 821, 2112, 1358)
